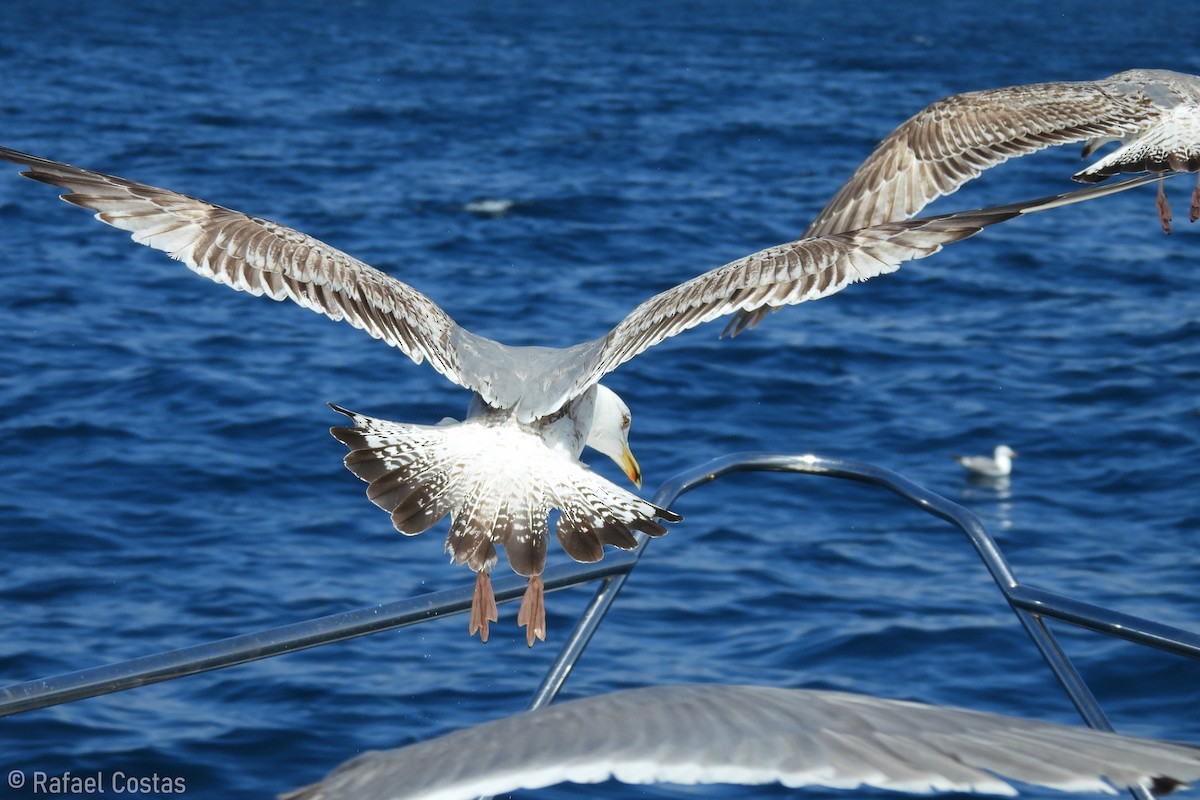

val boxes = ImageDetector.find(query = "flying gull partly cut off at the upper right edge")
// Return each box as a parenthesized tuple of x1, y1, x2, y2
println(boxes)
(726, 70, 1200, 333)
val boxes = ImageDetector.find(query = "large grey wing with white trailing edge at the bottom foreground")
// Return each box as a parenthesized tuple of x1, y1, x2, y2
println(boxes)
(281, 685, 1200, 800)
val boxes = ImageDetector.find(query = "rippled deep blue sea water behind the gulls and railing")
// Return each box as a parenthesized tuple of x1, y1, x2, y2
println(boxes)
(0, 0, 1200, 798)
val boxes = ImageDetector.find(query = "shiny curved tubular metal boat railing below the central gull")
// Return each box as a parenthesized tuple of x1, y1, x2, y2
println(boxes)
(0, 452, 1200, 800)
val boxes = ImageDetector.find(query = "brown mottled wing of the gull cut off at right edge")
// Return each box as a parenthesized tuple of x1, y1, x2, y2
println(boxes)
(805, 70, 1200, 236)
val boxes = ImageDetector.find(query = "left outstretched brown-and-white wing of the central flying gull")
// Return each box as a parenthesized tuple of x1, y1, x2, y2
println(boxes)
(0, 148, 469, 386)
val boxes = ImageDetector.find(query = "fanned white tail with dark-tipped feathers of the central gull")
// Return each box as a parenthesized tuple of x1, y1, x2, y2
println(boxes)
(330, 405, 680, 576)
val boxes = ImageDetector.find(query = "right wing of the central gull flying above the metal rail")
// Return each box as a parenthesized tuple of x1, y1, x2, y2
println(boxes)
(549, 175, 1158, 407)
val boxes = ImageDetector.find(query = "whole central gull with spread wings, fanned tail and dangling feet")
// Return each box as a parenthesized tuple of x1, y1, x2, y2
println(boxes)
(0, 149, 1152, 646)
